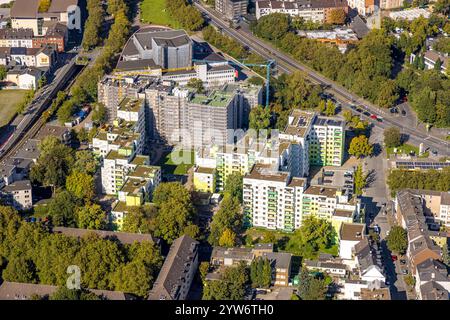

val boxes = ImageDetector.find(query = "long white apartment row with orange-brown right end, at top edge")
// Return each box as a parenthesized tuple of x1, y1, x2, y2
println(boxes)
(256, 0, 348, 23)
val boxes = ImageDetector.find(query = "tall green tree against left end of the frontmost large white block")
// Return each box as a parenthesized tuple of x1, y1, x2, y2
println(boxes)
(208, 194, 242, 245)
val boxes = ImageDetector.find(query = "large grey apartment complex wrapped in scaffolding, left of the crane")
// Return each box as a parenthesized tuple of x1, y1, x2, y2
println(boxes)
(98, 76, 262, 145)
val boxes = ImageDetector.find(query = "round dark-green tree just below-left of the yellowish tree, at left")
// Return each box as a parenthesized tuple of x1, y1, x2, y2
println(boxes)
(48, 191, 77, 227)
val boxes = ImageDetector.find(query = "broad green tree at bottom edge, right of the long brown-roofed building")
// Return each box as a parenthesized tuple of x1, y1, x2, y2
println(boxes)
(202, 263, 249, 300)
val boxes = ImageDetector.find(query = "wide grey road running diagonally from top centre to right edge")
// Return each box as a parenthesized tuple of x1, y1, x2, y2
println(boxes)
(194, 2, 450, 156)
